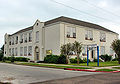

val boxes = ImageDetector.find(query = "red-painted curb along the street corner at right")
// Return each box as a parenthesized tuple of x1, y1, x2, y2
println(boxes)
(64, 68, 120, 73)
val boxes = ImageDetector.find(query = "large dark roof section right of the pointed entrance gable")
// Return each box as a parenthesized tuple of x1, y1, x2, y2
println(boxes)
(45, 16, 118, 34)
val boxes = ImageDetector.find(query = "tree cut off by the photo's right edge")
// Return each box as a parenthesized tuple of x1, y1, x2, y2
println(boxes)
(111, 39, 120, 64)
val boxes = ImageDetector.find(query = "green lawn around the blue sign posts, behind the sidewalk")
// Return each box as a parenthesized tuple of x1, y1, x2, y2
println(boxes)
(70, 61, 120, 67)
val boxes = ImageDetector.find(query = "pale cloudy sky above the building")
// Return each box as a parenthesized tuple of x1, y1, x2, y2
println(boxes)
(0, 0, 120, 47)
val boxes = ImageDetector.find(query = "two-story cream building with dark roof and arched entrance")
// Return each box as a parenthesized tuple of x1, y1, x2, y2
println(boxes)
(4, 16, 119, 61)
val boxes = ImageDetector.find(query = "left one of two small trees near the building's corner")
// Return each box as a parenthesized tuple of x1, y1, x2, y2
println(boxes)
(61, 43, 72, 64)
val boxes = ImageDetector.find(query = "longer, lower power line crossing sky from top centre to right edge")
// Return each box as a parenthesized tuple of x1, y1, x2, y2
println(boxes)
(50, 0, 120, 24)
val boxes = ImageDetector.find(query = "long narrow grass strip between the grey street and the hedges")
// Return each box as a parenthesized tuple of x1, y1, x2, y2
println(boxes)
(16, 62, 91, 69)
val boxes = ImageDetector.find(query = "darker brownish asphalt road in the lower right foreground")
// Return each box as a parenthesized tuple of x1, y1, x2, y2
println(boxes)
(36, 73, 120, 84)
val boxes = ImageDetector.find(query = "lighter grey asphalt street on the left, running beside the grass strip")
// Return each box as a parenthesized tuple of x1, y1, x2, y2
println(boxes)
(0, 63, 98, 84)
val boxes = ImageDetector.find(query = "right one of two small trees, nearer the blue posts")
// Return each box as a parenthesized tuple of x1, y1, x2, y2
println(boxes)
(72, 41, 82, 64)
